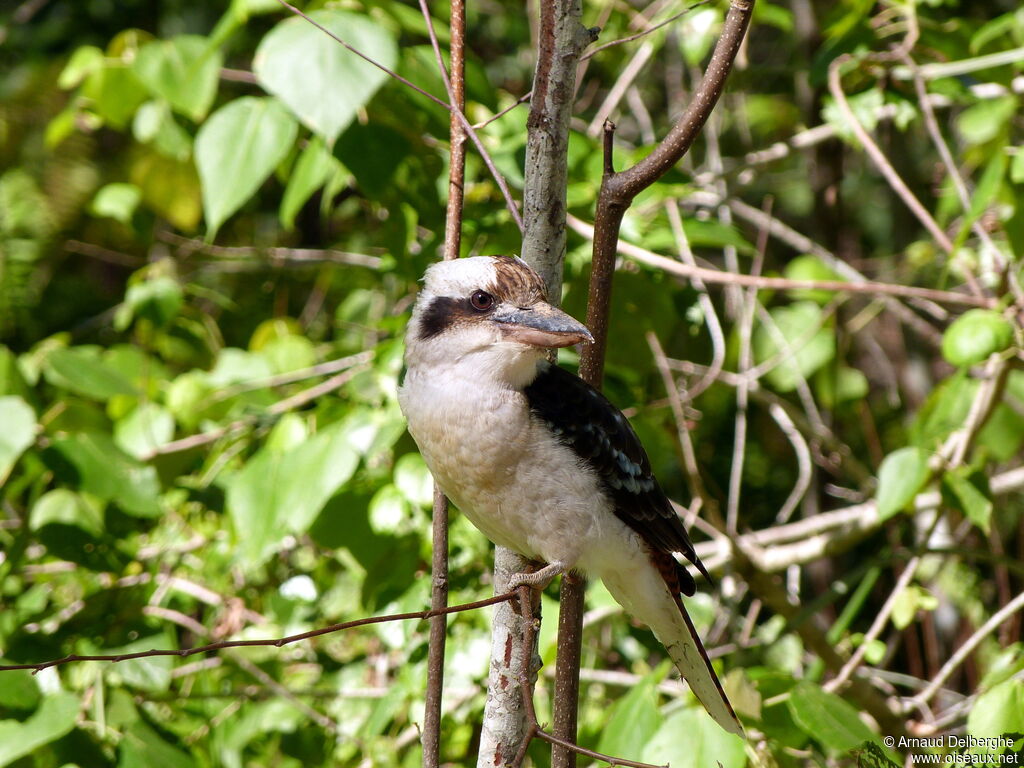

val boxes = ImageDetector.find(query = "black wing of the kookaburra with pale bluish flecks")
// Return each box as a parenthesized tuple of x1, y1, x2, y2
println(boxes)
(525, 362, 711, 595)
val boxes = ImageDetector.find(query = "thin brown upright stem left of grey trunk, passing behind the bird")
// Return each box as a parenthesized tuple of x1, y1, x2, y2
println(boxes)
(422, 0, 466, 768)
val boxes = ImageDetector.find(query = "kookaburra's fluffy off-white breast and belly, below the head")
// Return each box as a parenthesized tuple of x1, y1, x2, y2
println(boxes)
(398, 366, 639, 572)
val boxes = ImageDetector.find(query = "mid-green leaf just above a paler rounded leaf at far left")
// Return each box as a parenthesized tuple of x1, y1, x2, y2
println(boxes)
(52, 432, 161, 517)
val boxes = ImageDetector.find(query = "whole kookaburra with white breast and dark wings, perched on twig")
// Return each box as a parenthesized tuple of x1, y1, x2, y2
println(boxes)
(398, 256, 743, 735)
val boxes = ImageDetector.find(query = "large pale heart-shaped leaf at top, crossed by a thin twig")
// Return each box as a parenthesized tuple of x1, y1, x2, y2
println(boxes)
(253, 10, 397, 144)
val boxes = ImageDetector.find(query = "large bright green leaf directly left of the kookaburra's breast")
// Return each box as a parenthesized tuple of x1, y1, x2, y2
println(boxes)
(227, 423, 358, 566)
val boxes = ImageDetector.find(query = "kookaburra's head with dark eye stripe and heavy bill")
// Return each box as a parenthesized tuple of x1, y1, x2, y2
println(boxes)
(406, 256, 594, 385)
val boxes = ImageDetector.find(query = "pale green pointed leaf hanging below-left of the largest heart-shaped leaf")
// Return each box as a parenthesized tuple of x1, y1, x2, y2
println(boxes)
(196, 97, 301, 240)
